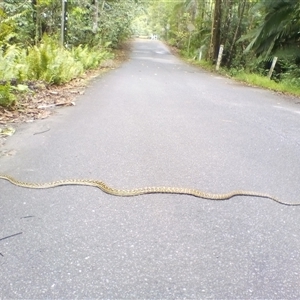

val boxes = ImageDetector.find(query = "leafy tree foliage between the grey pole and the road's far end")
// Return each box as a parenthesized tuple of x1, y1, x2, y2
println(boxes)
(67, 0, 138, 47)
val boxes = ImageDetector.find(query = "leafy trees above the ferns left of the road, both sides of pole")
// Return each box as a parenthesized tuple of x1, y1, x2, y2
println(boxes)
(0, 0, 139, 47)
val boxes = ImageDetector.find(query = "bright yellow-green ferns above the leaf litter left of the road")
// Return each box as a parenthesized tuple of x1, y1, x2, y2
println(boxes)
(0, 36, 112, 107)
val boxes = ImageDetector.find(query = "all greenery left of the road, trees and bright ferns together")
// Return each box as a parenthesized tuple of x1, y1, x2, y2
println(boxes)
(0, 0, 139, 106)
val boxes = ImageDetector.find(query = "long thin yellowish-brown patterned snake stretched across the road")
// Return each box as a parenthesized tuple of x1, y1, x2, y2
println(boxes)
(0, 174, 300, 206)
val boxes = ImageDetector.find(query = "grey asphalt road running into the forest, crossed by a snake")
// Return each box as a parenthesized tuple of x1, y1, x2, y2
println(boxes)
(0, 40, 300, 299)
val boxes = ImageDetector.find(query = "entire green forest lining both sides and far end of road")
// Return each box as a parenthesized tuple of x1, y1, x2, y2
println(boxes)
(0, 0, 300, 107)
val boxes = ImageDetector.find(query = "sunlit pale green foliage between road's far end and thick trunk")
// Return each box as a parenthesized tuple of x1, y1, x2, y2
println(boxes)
(147, 0, 212, 56)
